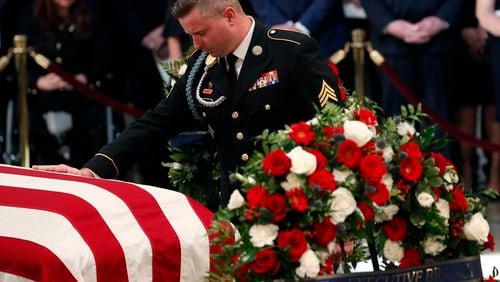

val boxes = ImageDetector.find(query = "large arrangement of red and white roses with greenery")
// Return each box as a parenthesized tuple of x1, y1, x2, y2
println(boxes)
(209, 97, 495, 281)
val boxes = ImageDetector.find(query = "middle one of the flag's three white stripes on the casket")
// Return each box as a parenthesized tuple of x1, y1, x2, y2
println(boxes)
(0, 173, 152, 281)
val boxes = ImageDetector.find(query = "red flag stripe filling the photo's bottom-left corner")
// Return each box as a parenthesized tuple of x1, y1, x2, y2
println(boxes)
(0, 236, 76, 282)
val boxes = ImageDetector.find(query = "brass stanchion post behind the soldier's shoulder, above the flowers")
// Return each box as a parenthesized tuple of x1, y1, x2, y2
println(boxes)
(351, 28, 366, 101)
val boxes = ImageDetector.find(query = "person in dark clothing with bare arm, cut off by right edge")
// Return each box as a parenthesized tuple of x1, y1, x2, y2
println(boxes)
(476, 0, 500, 191)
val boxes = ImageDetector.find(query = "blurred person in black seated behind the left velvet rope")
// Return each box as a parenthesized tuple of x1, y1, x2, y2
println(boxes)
(19, 0, 110, 165)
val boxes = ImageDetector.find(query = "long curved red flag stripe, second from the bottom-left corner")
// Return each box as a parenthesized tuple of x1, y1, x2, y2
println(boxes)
(0, 185, 128, 281)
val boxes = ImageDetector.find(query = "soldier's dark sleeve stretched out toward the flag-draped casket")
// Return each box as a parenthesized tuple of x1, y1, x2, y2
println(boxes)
(84, 66, 195, 178)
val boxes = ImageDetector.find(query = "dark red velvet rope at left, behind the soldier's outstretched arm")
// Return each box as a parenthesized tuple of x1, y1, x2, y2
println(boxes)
(47, 62, 144, 118)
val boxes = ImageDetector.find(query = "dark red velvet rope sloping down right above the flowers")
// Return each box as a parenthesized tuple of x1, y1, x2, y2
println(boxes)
(378, 61, 500, 152)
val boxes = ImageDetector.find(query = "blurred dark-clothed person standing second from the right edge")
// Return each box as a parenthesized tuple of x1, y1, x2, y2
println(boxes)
(455, 0, 498, 191)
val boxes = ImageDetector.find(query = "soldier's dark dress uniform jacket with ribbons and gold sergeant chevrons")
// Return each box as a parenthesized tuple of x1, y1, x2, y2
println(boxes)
(85, 22, 340, 184)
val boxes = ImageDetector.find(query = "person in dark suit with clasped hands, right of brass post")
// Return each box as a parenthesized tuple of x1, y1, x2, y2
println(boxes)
(362, 0, 462, 118)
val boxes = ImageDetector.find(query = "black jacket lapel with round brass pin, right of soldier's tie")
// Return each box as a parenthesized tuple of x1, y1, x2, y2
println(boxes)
(232, 21, 271, 108)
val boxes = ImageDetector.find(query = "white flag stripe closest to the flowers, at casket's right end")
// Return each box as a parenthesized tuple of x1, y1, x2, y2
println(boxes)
(137, 185, 210, 282)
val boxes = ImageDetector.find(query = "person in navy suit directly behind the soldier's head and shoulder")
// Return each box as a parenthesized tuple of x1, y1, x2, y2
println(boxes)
(250, 0, 348, 58)
